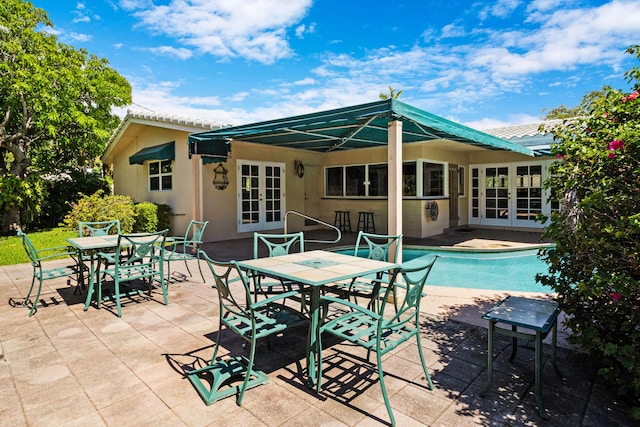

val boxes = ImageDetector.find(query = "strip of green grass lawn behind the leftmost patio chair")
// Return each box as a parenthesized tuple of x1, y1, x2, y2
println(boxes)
(0, 228, 78, 265)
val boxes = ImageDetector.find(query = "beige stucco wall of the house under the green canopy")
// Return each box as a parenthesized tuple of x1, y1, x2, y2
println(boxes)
(105, 124, 548, 242)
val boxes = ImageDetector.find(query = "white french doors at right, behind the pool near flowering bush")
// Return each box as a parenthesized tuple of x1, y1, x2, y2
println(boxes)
(469, 162, 550, 227)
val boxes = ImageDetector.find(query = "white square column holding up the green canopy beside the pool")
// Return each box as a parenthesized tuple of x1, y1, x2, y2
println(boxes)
(387, 120, 402, 263)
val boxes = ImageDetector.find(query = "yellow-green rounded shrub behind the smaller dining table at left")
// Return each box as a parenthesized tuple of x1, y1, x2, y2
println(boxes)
(63, 190, 136, 233)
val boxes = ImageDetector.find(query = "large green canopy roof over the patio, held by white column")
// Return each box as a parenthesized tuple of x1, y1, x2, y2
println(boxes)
(189, 99, 534, 160)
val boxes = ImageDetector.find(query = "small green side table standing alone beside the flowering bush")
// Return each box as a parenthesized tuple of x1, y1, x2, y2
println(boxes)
(480, 296, 562, 419)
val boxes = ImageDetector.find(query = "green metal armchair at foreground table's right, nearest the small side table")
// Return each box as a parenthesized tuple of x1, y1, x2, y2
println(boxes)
(316, 256, 437, 425)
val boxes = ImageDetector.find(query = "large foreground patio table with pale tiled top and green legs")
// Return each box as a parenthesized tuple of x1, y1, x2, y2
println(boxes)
(238, 250, 400, 386)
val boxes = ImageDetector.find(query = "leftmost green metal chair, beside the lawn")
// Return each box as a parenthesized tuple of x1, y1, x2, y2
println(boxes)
(18, 230, 78, 317)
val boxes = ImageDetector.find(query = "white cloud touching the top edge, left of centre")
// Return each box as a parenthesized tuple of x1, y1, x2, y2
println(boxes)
(127, 0, 311, 64)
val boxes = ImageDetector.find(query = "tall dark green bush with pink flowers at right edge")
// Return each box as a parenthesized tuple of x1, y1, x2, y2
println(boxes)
(538, 46, 640, 419)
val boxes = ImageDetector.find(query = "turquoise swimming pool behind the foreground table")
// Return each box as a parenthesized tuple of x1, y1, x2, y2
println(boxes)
(340, 246, 553, 293)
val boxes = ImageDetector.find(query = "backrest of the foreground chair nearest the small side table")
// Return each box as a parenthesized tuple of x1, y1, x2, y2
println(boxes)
(379, 255, 438, 327)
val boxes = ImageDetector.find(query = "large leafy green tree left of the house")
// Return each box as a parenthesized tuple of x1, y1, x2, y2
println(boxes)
(0, 0, 131, 231)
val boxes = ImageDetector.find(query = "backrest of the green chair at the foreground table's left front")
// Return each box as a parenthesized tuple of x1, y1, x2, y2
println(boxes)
(200, 250, 253, 320)
